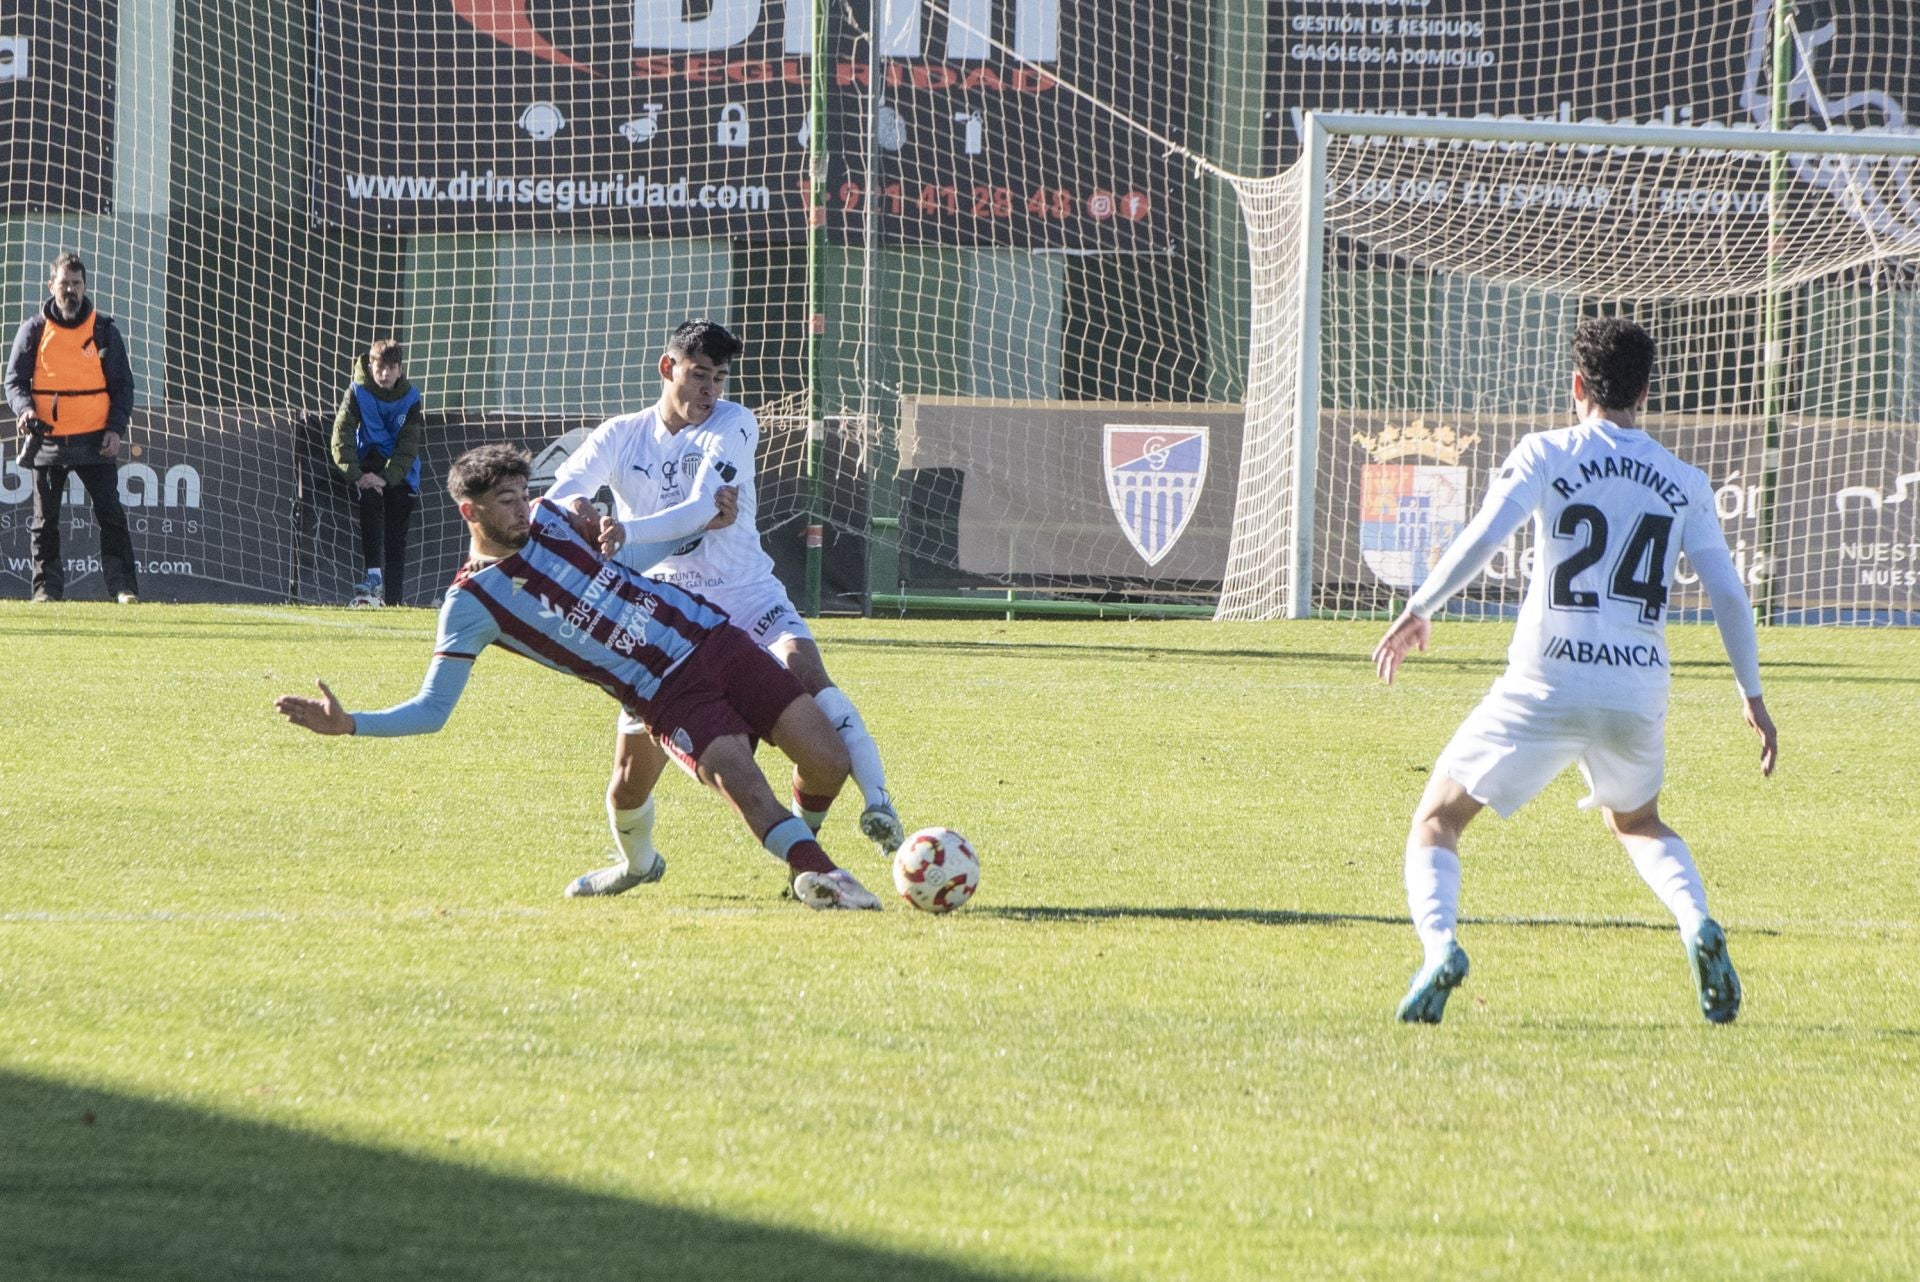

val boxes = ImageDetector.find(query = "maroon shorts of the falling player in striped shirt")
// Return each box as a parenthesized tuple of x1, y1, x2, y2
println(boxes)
(647, 624, 806, 770)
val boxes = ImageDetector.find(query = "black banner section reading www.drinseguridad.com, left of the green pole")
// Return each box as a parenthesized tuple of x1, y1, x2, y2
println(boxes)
(313, 0, 810, 238)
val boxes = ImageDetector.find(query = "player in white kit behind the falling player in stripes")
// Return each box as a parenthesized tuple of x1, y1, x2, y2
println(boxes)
(545, 321, 906, 896)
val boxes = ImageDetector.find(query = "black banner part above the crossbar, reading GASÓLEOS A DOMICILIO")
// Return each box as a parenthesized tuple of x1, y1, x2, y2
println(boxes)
(1267, 0, 1920, 169)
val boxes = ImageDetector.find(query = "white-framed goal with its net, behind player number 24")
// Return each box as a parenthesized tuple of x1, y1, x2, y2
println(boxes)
(1217, 113, 1920, 624)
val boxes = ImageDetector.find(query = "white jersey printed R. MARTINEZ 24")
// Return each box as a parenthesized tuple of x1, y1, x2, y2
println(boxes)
(1488, 418, 1730, 716)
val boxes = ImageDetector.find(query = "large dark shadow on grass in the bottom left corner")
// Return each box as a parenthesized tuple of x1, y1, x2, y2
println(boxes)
(0, 1073, 1036, 1282)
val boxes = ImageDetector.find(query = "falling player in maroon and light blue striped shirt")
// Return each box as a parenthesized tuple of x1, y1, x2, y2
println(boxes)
(275, 445, 879, 910)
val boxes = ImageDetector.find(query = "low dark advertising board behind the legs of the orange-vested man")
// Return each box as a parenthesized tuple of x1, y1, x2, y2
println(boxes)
(0, 416, 296, 601)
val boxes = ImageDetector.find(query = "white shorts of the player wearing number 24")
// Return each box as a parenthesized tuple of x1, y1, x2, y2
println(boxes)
(1434, 691, 1667, 819)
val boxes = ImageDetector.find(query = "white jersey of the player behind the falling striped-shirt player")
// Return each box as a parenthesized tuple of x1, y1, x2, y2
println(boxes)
(547, 401, 774, 591)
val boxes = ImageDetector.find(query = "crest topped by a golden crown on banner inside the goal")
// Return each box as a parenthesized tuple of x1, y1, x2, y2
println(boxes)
(1354, 418, 1480, 591)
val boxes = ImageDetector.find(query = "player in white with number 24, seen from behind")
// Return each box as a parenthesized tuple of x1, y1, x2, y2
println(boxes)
(1373, 319, 1778, 1023)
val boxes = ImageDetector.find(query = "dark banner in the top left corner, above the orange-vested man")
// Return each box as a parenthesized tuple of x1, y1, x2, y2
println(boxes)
(0, 0, 119, 213)
